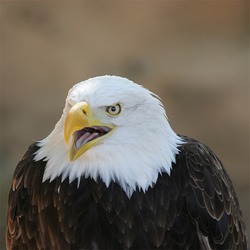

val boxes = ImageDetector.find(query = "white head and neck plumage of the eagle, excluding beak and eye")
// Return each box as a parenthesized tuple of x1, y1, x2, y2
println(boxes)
(35, 76, 182, 197)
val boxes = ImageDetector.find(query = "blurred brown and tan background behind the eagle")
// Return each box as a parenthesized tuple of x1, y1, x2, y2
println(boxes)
(0, 0, 250, 249)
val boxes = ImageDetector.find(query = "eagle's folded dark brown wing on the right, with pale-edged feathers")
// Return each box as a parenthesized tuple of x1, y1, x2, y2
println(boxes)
(177, 137, 247, 249)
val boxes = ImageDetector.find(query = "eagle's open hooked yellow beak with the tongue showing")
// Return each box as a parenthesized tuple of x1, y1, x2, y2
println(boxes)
(64, 102, 113, 161)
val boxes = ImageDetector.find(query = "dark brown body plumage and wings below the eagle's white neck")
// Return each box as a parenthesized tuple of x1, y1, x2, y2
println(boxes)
(6, 137, 247, 249)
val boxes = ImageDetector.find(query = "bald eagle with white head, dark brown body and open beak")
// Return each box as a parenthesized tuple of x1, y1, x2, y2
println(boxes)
(6, 76, 247, 249)
